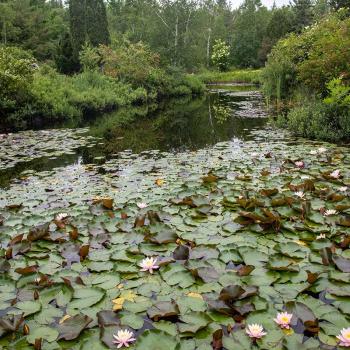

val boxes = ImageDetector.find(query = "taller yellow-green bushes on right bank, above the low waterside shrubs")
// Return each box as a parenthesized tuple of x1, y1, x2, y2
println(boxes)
(263, 15, 350, 99)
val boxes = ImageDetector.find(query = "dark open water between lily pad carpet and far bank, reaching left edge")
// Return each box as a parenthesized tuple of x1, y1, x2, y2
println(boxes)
(0, 84, 267, 187)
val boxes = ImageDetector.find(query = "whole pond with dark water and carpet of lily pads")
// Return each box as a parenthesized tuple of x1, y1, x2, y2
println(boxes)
(0, 85, 350, 350)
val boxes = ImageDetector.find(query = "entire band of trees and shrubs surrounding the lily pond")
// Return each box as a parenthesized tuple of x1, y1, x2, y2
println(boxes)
(0, 0, 349, 134)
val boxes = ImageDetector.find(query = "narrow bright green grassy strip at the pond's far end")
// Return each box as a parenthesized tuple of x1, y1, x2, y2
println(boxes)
(196, 69, 261, 84)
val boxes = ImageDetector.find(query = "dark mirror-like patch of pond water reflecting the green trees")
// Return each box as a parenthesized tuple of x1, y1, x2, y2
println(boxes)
(91, 86, 266, 155)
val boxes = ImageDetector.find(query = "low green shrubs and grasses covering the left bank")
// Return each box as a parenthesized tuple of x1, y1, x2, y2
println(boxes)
(0, 47, 204, 130)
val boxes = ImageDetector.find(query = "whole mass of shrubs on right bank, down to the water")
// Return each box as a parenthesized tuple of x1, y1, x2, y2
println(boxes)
(263, 9, 350, 140)
